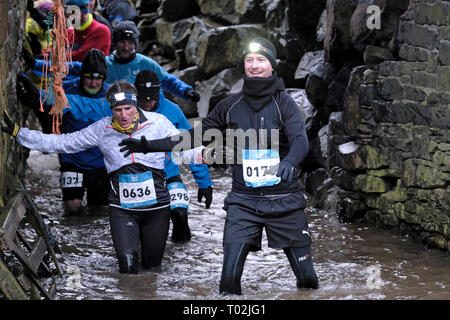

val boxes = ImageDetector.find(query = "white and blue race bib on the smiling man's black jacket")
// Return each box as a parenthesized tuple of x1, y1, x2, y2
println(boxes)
(242, 149, 281, 188)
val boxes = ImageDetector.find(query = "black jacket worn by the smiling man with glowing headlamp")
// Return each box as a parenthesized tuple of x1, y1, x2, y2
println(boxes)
(141, 75, 309, 196)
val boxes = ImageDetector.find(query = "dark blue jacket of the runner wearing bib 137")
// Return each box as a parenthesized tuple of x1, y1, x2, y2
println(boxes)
(58, 78, 109, 170)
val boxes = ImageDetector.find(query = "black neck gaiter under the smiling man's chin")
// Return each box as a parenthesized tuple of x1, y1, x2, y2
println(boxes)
(242, 73, 284, 111)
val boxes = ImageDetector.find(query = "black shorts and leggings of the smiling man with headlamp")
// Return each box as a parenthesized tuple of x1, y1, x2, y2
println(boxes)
(219, 192, 318, 294)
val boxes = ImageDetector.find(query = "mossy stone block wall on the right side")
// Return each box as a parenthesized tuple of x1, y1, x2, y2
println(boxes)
(336, 0, 450, 250)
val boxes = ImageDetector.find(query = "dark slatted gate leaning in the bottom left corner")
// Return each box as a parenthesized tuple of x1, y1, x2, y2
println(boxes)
(0, 190, 62, 300)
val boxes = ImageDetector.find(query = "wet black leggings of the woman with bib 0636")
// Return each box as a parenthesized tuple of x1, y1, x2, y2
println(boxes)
(109, 206, 170, 273)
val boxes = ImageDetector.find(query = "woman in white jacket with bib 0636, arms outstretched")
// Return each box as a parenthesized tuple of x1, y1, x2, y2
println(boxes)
(2, 82, 201, 273)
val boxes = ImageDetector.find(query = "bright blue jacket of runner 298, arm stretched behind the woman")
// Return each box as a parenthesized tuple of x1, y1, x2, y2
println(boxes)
(59, 93, 213, 188)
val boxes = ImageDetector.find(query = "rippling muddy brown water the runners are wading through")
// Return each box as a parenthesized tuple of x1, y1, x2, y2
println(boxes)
(25, 151, 450, 300)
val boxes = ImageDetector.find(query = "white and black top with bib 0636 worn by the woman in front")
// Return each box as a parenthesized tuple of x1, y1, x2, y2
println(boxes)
(17, 109, 202, 211)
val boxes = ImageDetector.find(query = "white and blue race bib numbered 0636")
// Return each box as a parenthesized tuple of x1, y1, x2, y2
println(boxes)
(119, 172, 158, 208)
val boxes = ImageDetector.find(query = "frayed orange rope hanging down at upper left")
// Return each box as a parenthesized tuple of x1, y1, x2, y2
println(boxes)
(40, 0, 72, 134)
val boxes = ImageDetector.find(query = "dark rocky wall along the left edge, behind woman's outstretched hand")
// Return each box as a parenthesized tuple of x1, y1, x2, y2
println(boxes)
(0, 0, 28, 209)
